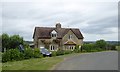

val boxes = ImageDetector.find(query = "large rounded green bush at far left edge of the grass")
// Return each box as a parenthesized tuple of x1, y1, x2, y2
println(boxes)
(2, 49, 24, 62)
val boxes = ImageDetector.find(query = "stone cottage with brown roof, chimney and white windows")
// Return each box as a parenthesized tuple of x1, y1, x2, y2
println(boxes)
(33, 23, 83, 51)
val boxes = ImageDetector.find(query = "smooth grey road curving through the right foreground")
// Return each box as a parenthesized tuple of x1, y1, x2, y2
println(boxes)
(55, 51, 118, 70)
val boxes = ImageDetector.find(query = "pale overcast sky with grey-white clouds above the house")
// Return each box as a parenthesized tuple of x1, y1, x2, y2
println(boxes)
(0, 0, 118, 41)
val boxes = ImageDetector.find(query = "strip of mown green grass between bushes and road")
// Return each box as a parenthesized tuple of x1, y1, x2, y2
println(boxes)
(2, 53, 80, 70)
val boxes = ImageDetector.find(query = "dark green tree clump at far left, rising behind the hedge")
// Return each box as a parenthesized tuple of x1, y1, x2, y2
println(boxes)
(0, 33, 27, 52)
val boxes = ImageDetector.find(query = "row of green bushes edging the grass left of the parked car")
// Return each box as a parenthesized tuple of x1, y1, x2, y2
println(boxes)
(2, 48, 43, 62)
